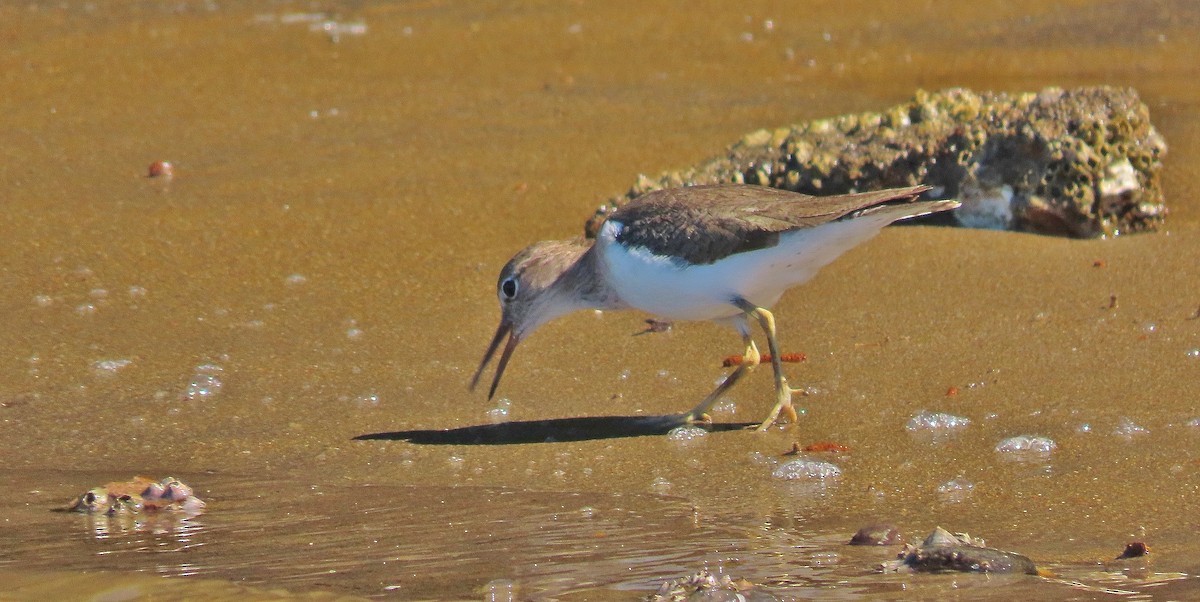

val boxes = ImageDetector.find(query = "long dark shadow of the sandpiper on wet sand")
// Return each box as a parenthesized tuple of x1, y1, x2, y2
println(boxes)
(354, 414, 755, 445)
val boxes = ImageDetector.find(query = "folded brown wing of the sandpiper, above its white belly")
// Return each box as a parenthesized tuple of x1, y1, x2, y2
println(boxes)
(608, 185, 929, 264)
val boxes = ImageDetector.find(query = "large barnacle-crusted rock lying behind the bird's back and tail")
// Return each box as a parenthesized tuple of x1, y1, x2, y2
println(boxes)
(587, 86, 1166, 237)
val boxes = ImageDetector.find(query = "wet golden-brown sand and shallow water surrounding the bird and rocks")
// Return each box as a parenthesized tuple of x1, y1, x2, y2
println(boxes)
(0, 0, 1200, 600)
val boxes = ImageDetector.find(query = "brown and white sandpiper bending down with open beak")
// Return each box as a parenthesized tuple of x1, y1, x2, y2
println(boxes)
(470, 185, 959, 431)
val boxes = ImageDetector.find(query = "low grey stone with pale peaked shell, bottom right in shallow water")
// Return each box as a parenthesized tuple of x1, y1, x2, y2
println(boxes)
(882, 526, 1040, 574)
